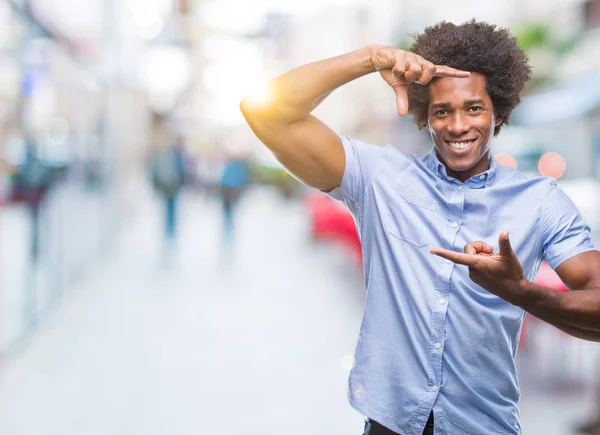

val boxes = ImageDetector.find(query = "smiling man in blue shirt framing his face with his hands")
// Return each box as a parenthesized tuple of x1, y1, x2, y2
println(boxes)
(241, 21, 600, 435)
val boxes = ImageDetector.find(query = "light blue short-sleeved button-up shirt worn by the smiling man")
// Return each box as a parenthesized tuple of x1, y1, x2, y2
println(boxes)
(330, 137, 595, 435)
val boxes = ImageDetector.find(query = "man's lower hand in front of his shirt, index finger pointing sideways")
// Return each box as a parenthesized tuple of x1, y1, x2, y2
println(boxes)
(431, 231, 527, 305)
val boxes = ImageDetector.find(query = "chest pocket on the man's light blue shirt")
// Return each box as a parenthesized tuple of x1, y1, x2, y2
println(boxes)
(382, 176, 439, 248)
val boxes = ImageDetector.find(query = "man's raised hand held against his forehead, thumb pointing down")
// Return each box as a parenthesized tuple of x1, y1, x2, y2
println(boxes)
(370, 46, 471, 116)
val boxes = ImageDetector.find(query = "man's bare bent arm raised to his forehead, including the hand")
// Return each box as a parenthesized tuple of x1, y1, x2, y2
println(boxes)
(240, 46, 469, 191)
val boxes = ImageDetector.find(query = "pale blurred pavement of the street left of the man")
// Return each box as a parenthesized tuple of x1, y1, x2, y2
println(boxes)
(0, 192, 362, 435)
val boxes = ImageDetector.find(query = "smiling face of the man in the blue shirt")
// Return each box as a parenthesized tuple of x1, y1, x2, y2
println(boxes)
(429, 74, 502, 182)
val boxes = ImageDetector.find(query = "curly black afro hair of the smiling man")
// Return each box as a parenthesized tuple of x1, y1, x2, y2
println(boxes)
(408, 20, 531, 136)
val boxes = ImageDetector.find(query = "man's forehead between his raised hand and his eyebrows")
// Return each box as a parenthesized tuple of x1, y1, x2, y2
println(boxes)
(429, 74, 491, 104)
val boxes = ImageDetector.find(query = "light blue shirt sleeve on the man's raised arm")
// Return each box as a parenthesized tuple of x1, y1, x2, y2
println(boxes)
(326, 136, 386, 209)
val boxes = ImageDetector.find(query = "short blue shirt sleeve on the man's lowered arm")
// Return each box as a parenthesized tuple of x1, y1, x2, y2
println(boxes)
(542, 180, 596, 269)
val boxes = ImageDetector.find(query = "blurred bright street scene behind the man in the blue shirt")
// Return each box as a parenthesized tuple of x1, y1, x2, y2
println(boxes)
(0, 0, 600, 435)
